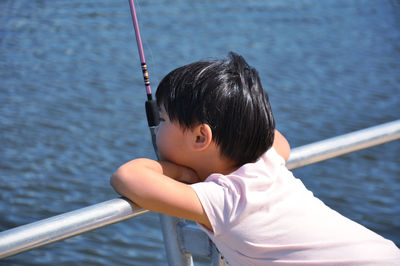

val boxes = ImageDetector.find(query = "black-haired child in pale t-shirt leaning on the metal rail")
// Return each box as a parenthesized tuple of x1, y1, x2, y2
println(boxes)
(111, 53, 400, 265)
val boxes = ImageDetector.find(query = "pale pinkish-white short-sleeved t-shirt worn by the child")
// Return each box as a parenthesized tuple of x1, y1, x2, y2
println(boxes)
(191, 148, 400, 266)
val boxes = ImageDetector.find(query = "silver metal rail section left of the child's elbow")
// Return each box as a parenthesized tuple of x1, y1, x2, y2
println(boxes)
(0, 198, 149, 259)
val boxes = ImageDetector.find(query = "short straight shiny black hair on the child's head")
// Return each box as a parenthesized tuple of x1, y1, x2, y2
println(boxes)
(156, 53, 275, 165)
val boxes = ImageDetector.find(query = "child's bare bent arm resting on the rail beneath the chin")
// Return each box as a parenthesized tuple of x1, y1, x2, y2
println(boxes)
(110, 159, 212, 230)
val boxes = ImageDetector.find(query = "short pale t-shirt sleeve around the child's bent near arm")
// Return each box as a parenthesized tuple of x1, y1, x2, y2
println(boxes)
(191, 182, 231, 236)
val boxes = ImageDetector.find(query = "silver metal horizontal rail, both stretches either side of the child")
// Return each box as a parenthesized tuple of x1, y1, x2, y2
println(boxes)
(0, 120, 400, 258)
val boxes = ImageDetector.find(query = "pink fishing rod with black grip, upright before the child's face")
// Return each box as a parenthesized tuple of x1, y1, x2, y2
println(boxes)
(129, 0, 160, 155)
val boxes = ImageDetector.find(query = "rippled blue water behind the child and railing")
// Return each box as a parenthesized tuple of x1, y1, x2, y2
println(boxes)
(0, 0, 400, 265)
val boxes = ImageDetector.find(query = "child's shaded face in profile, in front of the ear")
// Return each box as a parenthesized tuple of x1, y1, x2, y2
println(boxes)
(155, 106, 190, 165)
